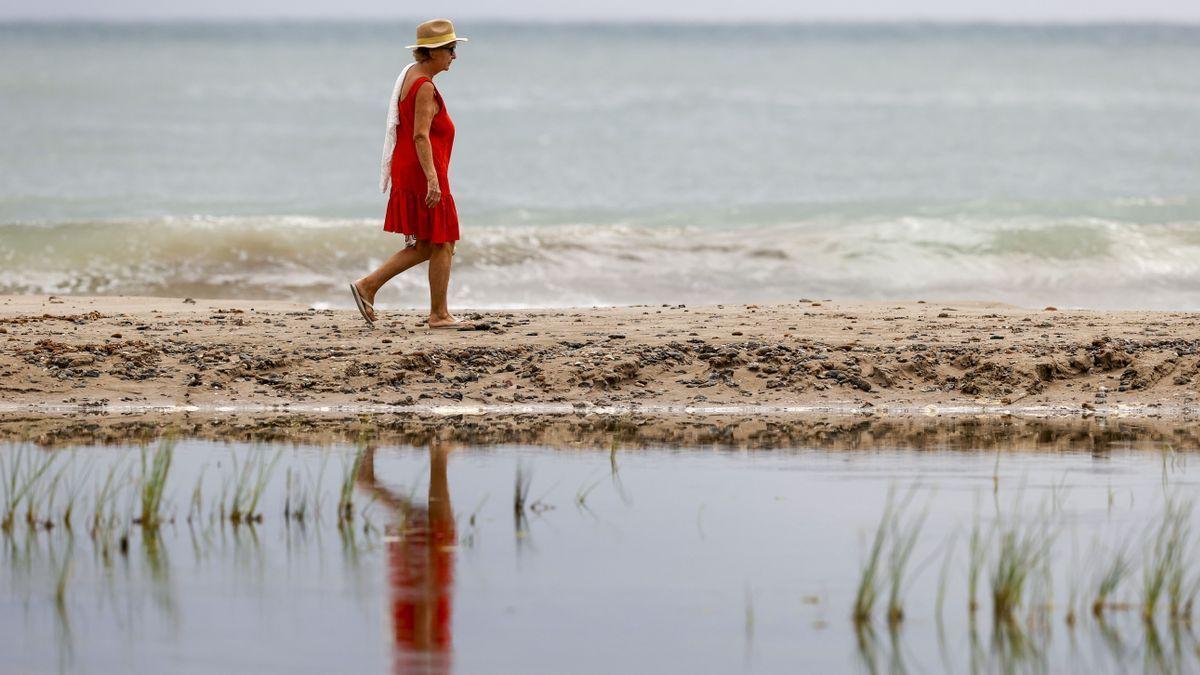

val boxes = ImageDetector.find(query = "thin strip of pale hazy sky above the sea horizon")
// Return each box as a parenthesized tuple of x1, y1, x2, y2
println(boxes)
(7, 0, 1200, 22)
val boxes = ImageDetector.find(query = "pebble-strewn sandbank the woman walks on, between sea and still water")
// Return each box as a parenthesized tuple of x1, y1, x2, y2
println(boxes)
(0, 295, 1200, 418)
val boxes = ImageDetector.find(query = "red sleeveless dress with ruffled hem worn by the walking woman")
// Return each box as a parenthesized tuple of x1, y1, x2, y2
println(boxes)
(383, 77, 458, 244)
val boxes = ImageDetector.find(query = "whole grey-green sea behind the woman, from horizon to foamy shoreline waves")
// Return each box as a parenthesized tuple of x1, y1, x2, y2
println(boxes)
(0, 22, 1200, 309)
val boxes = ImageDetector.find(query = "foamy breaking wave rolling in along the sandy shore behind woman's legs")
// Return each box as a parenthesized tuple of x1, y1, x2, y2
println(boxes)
(0, 215, 1200, 310)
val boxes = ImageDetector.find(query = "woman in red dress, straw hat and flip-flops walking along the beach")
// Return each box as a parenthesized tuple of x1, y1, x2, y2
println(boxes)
(350, 19, 467, 328)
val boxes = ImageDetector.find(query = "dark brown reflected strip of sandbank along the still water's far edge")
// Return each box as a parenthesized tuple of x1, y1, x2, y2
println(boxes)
(7, 412, 1200, 455)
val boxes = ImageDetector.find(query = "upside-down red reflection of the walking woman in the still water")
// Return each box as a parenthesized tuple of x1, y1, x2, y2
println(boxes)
(359, 444, 457, 673)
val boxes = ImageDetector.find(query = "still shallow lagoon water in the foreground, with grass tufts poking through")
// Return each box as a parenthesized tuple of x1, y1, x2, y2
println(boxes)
(0, 432, 1198, 673)
